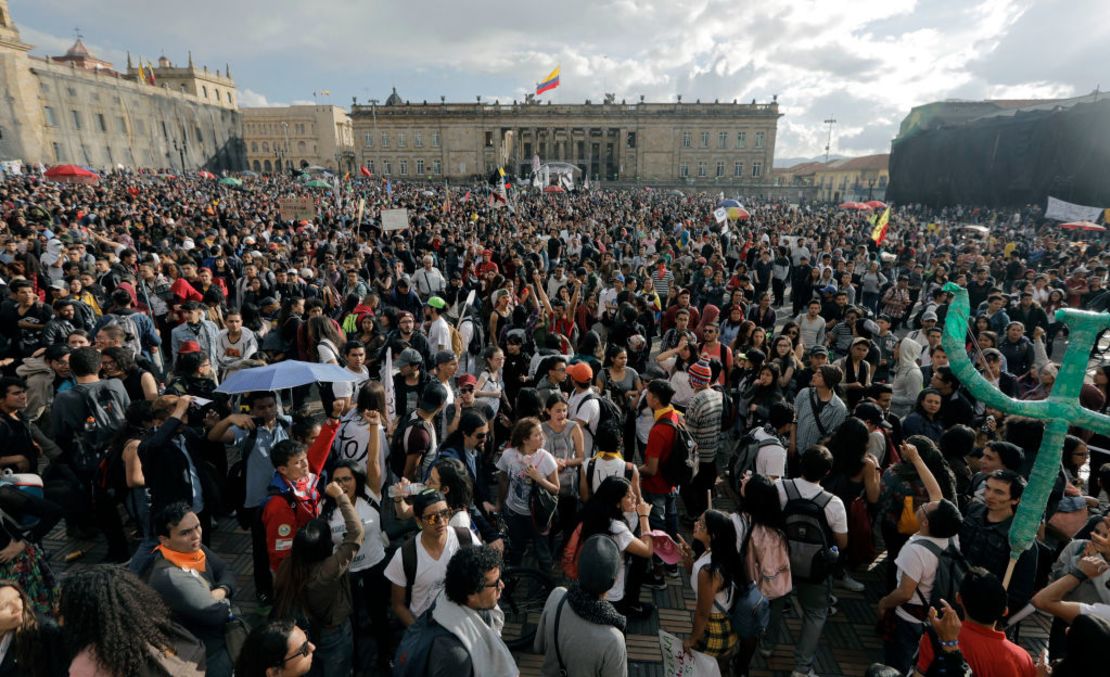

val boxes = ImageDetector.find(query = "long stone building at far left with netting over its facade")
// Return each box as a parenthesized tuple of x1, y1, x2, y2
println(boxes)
(0, 0, 244, 171)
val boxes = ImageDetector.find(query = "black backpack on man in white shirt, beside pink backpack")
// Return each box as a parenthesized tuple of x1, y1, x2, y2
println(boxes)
(783, 479, 837, 583)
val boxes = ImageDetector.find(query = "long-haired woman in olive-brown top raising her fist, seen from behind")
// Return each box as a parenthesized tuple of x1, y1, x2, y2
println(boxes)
(273, 482, 363, 675)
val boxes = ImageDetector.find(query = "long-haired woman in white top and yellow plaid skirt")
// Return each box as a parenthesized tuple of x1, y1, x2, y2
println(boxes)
(682, 509, 750, 674)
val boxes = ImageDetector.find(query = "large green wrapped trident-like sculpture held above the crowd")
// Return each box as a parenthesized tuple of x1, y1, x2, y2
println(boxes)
(941, 282, 1110, 587)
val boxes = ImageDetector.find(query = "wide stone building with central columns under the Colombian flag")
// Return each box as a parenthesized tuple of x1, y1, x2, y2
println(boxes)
(351, 89, 779, 186)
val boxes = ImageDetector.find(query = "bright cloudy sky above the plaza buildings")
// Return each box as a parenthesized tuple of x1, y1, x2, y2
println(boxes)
(9, 0, 1110, 158)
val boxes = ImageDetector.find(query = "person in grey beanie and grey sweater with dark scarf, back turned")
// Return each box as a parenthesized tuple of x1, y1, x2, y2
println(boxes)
(533, 535, 628, 677)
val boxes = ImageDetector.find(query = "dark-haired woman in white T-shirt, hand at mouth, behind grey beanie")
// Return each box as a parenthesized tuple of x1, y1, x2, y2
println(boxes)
(571, 476, 655, 618)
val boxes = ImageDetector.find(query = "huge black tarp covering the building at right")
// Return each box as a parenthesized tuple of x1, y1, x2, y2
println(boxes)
(886, 94, 1110, 206)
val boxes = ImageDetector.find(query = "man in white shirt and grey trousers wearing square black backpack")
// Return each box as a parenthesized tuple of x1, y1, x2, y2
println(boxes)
(777, 445, 848, 677)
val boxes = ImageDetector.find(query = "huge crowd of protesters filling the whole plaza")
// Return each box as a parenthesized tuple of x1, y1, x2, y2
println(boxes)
(0, 164, 1110, 677)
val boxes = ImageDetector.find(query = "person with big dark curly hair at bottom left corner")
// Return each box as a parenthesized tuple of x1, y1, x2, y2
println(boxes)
(58, 564, 205, 677)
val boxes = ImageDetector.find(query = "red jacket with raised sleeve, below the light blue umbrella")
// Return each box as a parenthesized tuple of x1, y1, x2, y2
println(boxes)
(262, 418, 340, 573)
